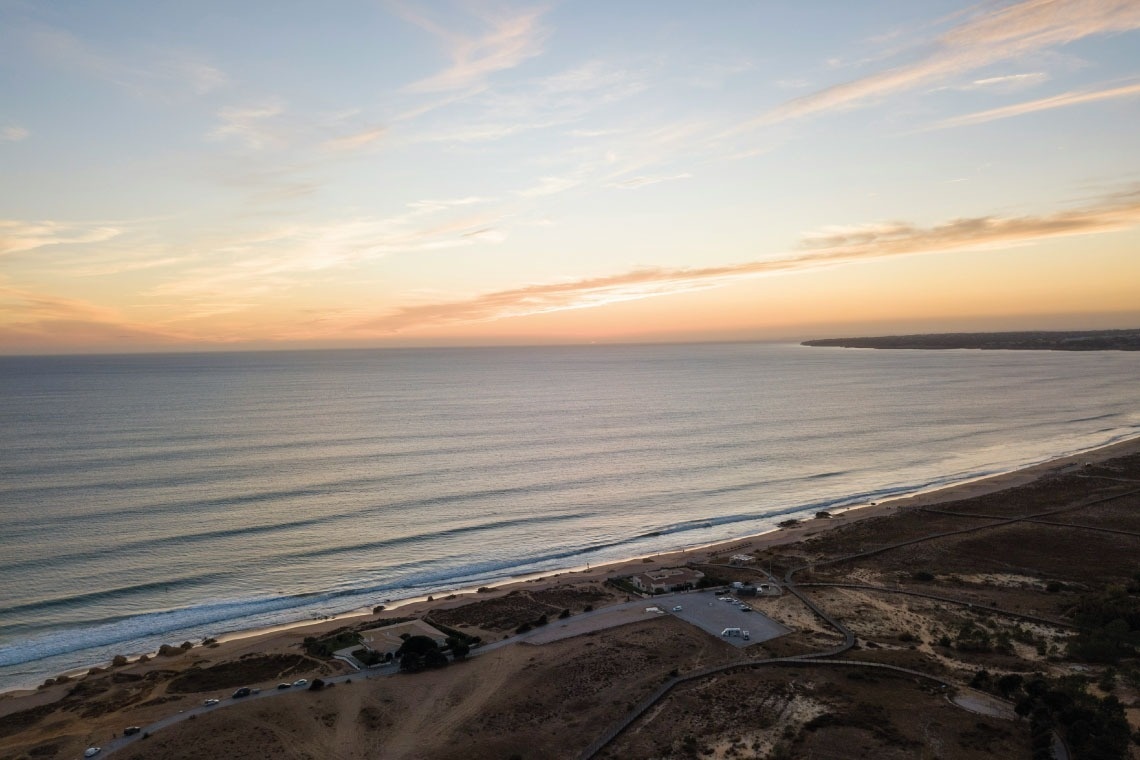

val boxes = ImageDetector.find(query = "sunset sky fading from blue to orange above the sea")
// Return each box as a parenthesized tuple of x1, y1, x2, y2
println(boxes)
(0, 0, 1140, 354)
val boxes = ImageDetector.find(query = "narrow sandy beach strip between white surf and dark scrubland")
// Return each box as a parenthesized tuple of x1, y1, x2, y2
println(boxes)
(0, 434, 1140, 697)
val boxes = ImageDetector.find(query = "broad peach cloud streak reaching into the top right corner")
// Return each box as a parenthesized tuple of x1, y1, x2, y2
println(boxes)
(746, 0, 1140, 128)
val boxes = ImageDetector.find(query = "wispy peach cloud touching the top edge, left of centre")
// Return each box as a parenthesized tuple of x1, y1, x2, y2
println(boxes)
(393, 3, 545, 92)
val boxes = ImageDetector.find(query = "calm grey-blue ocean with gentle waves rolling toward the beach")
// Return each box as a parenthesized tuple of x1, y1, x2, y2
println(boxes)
(0, 344, 1140, 689)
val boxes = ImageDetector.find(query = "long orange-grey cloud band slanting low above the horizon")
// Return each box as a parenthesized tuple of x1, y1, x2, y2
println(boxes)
(355, 193, 1140, 335)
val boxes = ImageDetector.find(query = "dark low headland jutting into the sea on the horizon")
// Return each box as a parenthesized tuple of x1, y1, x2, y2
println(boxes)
(803, 329, 1140, 351)
